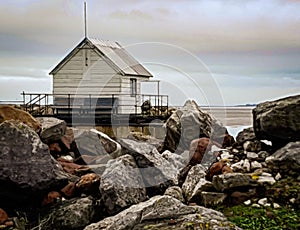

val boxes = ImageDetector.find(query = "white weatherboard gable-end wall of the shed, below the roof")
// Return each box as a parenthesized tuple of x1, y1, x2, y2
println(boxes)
(53, 45, 121, 95)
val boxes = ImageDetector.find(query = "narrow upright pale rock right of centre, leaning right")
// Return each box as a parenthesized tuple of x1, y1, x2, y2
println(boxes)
(182, 164, 206, 201)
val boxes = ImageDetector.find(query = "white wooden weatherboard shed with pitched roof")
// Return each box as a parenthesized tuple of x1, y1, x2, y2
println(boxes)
(50, 37, 152, 114)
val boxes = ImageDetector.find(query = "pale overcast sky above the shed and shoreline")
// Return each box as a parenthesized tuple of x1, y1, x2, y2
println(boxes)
(0, 0, 300, 105)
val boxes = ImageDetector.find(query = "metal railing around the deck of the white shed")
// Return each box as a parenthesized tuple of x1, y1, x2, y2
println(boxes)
(21, 92, 169, 116)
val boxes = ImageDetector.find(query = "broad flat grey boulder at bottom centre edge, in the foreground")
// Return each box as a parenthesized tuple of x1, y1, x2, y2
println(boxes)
(84, 196, 239, 230)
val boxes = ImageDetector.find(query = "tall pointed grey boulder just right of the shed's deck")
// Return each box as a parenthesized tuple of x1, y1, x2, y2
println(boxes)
(164, 100, 227, 152)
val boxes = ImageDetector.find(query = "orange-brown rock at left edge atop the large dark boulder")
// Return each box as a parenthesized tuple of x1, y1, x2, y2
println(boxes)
(0, 105, 41, 132)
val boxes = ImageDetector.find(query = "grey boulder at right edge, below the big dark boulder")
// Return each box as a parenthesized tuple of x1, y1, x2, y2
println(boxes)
(266, 141, 300, 177)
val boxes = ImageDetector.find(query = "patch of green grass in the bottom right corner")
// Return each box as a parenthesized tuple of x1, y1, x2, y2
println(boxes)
(219, 205, 300, 230)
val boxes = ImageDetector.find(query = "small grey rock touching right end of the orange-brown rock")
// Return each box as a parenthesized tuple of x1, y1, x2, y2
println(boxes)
(37, 117, 67, 144)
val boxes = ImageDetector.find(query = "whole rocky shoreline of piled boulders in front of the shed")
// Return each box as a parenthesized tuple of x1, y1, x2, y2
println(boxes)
(0, 96, 300, 230)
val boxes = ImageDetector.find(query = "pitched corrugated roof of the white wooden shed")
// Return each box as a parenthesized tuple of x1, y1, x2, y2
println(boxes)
(49, 38, 152, 77)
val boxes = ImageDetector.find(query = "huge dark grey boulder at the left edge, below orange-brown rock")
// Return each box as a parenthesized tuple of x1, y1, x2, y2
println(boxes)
(0, 121, 67, 208)
